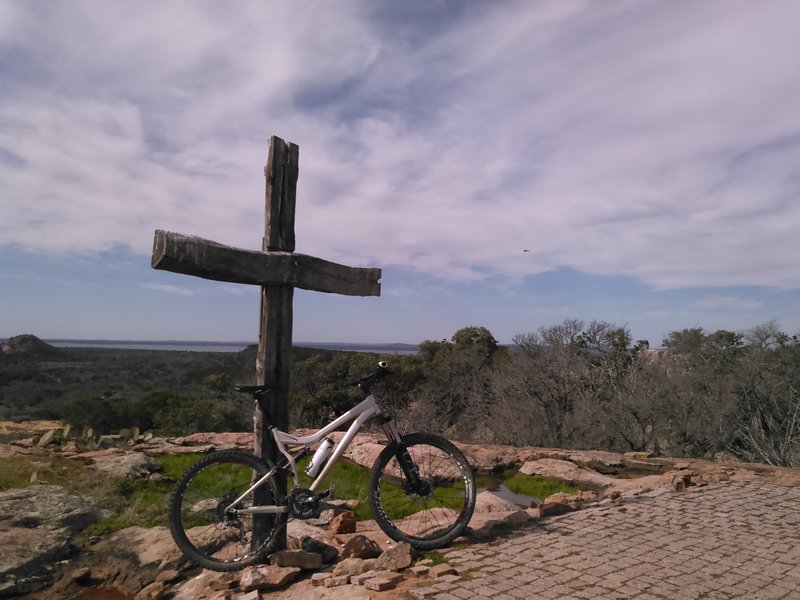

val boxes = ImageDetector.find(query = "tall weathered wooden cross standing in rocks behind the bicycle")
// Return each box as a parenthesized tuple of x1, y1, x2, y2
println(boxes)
(152, 136, 381, 550)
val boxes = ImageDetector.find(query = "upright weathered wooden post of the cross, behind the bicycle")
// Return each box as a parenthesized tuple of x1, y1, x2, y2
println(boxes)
(253, 136, 299, 550)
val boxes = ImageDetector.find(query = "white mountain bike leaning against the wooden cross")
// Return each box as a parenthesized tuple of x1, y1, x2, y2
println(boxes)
(169, 361, 475, 571)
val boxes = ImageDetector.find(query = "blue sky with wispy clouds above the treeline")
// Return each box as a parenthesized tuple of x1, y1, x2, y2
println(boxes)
(0, 0, 800, 346)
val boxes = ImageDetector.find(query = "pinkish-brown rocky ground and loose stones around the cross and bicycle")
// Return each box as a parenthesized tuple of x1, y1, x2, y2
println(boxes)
(0, 430, 800, 600)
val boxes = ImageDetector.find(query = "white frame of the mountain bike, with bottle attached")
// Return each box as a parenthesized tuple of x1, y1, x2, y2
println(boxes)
(226, 394, 400, 514)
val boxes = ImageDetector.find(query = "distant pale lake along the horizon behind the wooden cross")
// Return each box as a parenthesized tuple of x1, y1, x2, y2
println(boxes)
(43, 340, 417, 354)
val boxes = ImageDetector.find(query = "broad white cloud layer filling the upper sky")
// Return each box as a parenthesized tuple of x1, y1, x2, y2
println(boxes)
(0, 0, 800, 288)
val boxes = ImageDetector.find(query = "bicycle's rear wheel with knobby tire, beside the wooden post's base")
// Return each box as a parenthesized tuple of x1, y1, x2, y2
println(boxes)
(169, 450, 281, 571)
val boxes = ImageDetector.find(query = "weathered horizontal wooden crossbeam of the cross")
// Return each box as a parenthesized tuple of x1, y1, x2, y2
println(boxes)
(152, 229, 381, 296)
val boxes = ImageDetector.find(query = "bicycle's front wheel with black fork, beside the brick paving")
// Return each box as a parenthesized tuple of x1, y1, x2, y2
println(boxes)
(369, 433, 475, 550)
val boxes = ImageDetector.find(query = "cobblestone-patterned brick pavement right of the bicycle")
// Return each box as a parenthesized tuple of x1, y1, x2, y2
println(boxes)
(410, 481, 800, 600)
